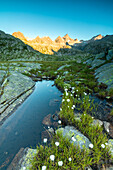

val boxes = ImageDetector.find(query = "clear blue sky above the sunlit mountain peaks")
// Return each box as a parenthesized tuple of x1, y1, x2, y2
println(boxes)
(0, 0, 113, 40)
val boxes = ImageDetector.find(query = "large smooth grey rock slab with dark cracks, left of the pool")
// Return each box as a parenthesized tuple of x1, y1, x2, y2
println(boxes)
(0, 72, 35, 122)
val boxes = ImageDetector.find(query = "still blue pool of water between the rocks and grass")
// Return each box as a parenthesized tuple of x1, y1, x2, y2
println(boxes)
(0, 81, 61, 170)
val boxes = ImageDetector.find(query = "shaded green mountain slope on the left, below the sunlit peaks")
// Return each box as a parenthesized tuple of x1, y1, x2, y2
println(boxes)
(0, 31, 40, 60)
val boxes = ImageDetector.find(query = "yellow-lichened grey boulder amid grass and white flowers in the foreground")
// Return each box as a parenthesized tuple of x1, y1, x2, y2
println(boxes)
(56, 126, 91, 149)
